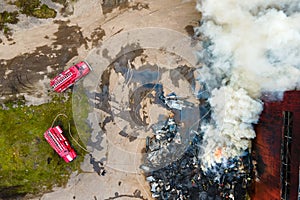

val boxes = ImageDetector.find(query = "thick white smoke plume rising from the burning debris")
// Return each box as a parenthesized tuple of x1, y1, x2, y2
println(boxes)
(196, 0, 300, 168)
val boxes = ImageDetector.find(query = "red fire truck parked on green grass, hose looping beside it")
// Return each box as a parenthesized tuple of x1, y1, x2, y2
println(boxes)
(44, 126, 76, 163)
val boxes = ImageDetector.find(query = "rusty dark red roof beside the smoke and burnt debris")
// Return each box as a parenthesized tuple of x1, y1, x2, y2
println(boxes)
(251, 91, 300, 200)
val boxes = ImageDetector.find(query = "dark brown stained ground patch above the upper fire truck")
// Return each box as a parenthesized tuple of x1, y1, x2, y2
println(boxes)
(0, 21, 86, 99)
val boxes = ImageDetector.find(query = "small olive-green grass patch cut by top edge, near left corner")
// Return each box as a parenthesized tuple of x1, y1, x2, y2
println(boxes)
(14, 0, 56, 19)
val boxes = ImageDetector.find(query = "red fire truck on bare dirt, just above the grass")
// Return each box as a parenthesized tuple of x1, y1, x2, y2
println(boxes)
(50, 61, 92, 92)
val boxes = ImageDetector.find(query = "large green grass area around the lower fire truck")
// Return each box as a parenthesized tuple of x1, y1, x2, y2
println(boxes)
(0, 96, 85, 198)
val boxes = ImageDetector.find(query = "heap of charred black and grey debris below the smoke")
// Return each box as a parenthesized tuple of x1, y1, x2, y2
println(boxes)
(141, 87, 253, 200)
